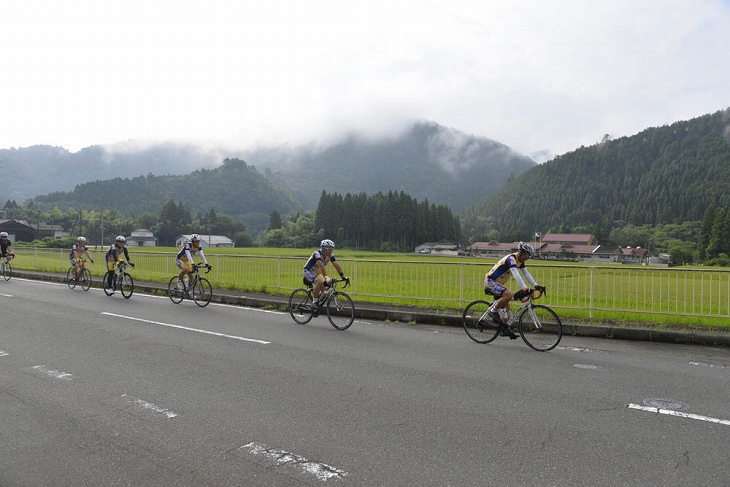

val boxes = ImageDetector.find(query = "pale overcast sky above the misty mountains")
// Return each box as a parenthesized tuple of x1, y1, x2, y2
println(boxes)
(0, 0, 730, 162)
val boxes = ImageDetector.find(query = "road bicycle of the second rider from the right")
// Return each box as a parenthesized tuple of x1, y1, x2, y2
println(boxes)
(289, 279, 355, 330)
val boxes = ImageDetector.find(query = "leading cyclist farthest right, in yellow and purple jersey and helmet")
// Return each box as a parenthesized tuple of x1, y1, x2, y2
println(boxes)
(484, 242, 545, 340)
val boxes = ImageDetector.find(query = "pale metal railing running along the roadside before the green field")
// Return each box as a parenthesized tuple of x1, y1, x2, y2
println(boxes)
(15, 248, 730, 318)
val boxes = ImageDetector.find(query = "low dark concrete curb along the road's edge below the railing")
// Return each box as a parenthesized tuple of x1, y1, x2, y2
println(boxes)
(13, 270, 730, 347)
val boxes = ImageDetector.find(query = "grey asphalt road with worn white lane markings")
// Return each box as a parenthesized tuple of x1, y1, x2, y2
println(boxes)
(0, 278, 730, 487)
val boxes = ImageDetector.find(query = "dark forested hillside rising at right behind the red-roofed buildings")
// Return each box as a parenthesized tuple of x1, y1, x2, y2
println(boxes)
(460, 109, 730, 241)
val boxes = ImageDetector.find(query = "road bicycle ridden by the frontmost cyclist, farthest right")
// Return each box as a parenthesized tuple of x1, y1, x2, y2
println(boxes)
(462, 289, 563, 352)
